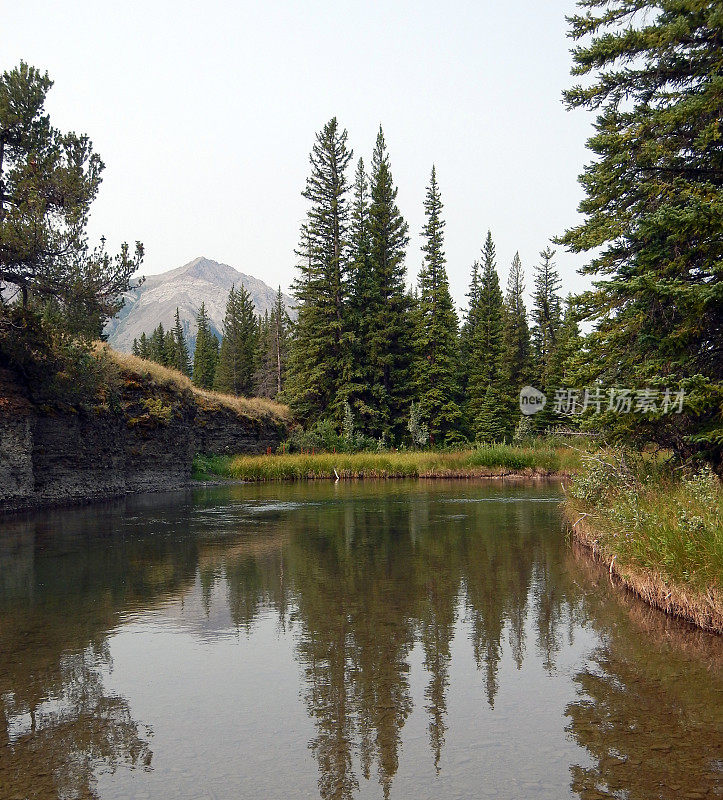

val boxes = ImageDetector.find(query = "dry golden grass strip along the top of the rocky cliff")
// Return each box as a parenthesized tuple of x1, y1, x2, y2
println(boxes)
(98, 344, 291, 422)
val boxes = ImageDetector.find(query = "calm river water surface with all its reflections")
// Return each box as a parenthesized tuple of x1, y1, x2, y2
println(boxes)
(0, 482, 723, 800)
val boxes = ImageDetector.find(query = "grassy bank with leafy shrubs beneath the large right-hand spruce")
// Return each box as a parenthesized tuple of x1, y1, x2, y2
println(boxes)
(566, 453, 723, 632)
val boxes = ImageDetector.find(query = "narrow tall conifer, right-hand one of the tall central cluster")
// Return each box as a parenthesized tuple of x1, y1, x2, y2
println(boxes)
(368, 127, 413, 436)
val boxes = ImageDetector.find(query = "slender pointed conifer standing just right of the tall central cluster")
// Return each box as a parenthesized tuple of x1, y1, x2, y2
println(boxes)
(415, 167, 462, 444)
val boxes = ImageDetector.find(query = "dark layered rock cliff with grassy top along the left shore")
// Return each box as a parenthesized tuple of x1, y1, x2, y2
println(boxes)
(0, 359, 286, 513)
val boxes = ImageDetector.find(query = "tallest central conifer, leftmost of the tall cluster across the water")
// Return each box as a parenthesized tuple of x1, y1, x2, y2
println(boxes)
(285, 118, 352, 422)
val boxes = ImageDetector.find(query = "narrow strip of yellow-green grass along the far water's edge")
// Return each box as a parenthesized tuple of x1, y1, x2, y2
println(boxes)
(194, 445, 580, 481)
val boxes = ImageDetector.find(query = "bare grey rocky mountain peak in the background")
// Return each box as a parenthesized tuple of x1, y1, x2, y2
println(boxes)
(105, 256, 293, 352)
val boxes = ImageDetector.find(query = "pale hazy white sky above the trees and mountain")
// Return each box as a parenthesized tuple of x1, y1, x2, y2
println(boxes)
(0, 0, 591, 304)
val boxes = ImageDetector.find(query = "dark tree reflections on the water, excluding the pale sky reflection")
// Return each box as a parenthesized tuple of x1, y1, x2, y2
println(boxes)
(0, 482, 721, 800)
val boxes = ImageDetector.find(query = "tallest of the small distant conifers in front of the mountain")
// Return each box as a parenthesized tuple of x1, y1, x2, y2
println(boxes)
(214, 285, 258, 397)
